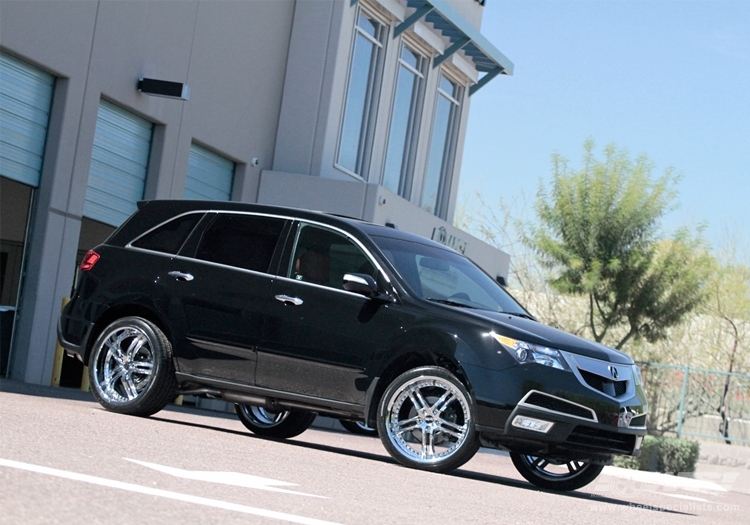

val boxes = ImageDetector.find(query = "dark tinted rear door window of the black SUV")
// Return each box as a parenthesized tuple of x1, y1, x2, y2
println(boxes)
(196, 213, 285, 272)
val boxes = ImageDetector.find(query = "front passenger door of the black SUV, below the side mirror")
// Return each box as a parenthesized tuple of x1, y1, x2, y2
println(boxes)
(256, 222, 398, 405)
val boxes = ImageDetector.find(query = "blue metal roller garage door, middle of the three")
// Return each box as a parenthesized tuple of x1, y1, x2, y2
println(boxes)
(83, 101, 154, 226)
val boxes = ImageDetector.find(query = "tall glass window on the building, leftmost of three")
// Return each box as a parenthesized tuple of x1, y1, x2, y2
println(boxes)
(337, 12, 386, 178)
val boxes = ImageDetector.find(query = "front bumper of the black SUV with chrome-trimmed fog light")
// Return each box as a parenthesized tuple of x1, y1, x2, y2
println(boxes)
(467, 359, 647, 460)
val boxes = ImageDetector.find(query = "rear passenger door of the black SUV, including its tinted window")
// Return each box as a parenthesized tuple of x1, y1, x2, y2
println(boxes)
(159, 212, 289, 384)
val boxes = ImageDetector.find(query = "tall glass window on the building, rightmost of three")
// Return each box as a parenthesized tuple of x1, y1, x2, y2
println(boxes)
(420, 75, 461, 218)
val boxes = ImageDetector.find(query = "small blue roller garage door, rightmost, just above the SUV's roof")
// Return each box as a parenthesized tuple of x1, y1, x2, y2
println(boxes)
(184, 144, 234, 201)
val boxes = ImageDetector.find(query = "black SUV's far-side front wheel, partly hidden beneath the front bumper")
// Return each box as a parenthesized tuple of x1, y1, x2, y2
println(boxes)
(510, 452, 604, 491)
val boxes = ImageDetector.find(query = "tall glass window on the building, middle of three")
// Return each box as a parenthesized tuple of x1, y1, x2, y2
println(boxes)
(383, 46, 426, 199)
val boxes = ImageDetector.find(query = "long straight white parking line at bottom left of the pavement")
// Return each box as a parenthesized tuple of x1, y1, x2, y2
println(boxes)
(0, 458, 344, 525)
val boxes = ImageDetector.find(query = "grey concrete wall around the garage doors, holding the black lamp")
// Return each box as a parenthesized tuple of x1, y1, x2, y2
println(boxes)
(0, 0, 295, 384)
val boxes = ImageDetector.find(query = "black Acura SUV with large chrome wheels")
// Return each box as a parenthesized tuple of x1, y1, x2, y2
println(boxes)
(58, 200, 646, 490)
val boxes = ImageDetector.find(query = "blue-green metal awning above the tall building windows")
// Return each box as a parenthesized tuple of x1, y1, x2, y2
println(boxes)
(352, 0, 513, 95)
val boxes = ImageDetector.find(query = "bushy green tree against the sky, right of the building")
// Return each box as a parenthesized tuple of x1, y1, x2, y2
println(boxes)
(525, 140, 711, 348)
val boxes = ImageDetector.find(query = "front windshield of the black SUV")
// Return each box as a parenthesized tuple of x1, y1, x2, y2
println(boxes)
(373, 236, 528, 317)
